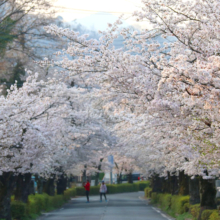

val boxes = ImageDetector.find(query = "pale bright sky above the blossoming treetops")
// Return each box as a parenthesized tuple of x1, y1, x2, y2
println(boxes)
(55, 0, 142, 30)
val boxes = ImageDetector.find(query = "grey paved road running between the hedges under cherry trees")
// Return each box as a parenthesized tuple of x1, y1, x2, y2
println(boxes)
(39, 192, 171, 220)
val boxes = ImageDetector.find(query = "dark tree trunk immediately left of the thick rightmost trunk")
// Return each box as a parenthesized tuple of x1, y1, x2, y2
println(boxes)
(189, 176, 200, 205)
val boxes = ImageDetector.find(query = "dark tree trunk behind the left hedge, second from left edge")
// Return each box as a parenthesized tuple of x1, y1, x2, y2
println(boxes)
(15, 173, 31, 203)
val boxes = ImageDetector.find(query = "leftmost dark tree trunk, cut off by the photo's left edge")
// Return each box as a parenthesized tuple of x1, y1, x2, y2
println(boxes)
(0, 172, 16, 220)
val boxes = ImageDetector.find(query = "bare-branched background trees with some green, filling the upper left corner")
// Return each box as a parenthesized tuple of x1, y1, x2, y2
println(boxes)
(0, 0, 59, 91)
